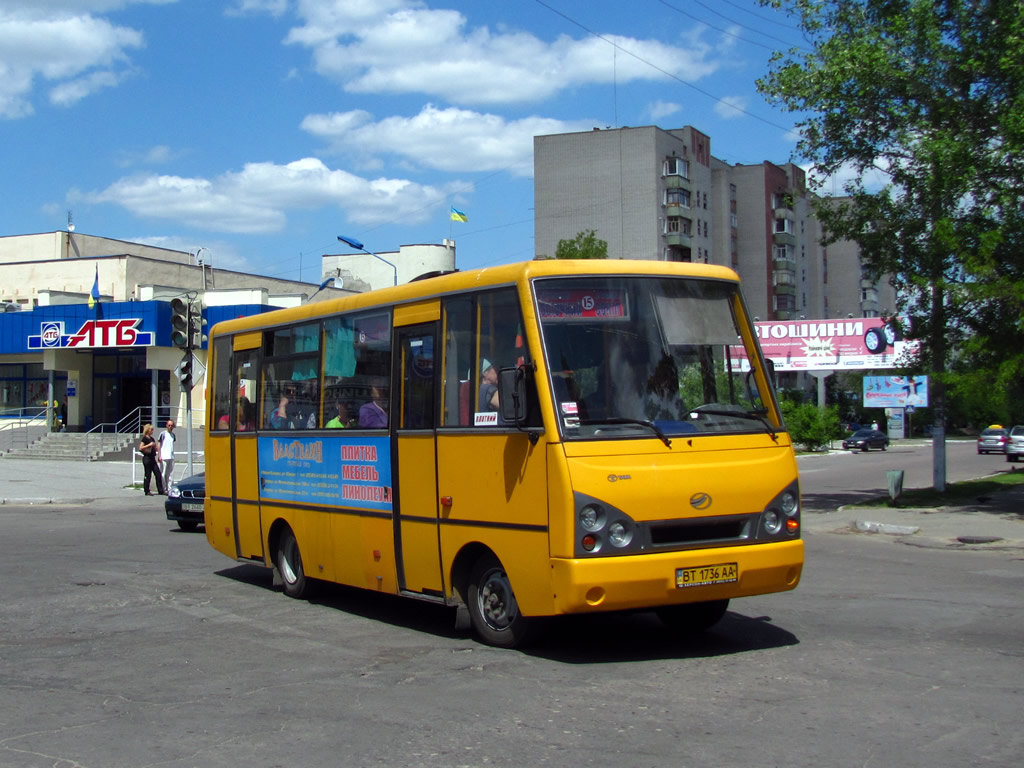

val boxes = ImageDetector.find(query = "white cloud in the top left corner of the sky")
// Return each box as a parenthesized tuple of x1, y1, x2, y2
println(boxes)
(0, 7, 144, 118)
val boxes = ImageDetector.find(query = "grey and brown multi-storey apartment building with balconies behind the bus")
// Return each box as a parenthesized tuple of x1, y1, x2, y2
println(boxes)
(534, 126, 895, 321)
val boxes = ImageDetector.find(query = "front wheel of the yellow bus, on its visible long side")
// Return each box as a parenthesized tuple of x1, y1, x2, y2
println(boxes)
(466, 552, 534, 648)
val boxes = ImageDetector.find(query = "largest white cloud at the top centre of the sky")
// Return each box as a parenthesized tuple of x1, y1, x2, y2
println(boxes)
(286, 0, 718, 104)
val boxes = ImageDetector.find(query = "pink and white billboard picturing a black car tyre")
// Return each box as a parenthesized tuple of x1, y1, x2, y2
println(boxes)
(733, 317, 914, 371)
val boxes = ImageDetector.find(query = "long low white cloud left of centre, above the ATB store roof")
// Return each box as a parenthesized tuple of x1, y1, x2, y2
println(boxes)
(82, 158, 471, 233)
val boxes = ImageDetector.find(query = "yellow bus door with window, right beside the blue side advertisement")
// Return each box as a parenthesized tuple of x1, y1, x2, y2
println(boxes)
(391, 319, 443, 596)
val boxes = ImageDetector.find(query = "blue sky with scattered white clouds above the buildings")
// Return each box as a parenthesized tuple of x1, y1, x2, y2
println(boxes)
(0, 0, 815, 283)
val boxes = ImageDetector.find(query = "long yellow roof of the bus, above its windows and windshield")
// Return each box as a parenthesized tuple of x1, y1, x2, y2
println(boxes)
(211, 259, 739, 336)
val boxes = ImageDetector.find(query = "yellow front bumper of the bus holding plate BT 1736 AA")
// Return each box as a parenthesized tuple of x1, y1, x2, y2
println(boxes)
(551, 539, 804, 614)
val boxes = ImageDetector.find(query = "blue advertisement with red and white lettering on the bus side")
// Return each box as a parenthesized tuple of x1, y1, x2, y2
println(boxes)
(258, 435, 392, 512)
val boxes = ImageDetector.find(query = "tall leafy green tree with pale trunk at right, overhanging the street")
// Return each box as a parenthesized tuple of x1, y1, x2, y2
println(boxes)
(758, 0, 1024, 490)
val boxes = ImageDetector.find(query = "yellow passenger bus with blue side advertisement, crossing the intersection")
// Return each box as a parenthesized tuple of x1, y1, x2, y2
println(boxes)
(206, 260, 804, 647)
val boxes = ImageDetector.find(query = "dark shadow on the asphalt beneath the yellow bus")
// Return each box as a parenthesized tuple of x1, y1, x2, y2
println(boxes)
(216, 565, 800, 664)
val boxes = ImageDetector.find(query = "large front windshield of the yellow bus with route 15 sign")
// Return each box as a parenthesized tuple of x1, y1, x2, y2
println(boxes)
(535, 276, 781, 442)
